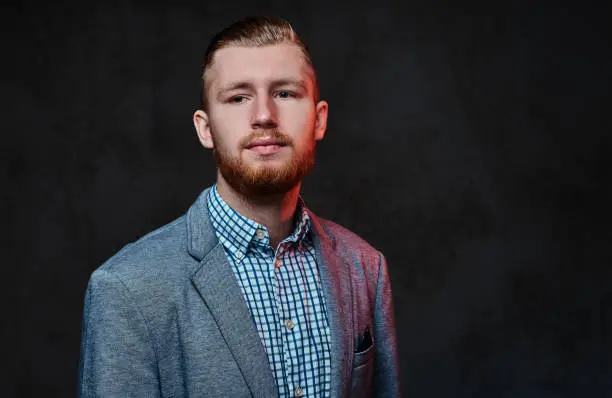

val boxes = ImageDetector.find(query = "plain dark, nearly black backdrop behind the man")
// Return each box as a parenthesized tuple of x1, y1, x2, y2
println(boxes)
(0, 1, 612, 397)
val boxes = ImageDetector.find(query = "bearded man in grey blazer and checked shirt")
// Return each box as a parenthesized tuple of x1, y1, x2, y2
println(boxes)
(79, 17, 400, 397)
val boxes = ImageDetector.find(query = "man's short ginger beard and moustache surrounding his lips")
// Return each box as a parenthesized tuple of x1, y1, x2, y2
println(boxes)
(212, 130, 315, 198)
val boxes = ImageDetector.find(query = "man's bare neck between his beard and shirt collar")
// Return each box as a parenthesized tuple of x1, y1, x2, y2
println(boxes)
(217, 173, 301, 248)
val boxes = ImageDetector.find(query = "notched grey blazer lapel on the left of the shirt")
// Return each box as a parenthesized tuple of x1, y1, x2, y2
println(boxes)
(187, 191, 278, 397)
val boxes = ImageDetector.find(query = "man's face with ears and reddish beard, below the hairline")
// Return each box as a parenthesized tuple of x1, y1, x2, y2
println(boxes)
(194, 43, 327, 196)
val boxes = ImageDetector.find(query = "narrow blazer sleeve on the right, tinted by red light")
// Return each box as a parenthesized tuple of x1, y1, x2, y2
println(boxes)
(374, 253, 402, 397)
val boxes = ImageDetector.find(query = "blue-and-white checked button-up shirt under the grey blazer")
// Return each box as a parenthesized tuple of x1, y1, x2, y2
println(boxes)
(208, 184, 331, 397)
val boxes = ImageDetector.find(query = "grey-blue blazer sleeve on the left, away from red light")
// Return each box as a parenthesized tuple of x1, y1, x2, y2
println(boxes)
(77, 270, 160, 397)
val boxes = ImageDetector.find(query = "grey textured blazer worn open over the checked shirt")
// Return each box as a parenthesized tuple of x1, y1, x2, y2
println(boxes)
(78, 190, 400, 397)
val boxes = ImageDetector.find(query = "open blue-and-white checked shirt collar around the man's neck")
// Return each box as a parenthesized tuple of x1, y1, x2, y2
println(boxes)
(208, 184, 311, 259)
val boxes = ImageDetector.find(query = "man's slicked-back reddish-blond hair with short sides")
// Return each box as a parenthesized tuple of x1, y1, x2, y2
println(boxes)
(200, 16, 319, 111)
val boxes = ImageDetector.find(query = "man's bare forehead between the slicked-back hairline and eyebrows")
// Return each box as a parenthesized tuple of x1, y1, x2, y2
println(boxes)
(207, 43, 311, 90)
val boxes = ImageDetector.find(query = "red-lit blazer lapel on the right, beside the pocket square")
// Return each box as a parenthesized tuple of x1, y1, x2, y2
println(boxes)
(309, 215, 354, 397)
